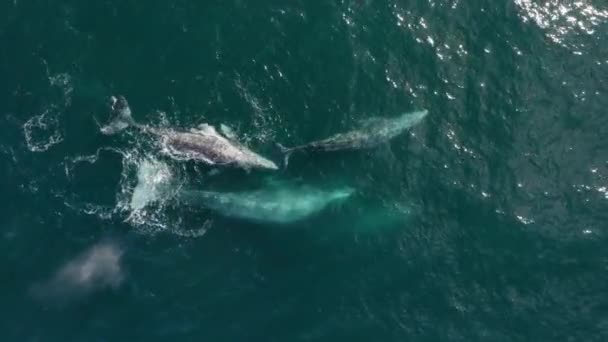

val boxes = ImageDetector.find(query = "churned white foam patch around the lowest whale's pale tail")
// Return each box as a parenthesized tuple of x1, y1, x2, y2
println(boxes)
(64, 135, 212, 238)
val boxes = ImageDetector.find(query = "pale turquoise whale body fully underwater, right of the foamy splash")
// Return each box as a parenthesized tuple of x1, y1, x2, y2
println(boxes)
(177, 184, 354, 224)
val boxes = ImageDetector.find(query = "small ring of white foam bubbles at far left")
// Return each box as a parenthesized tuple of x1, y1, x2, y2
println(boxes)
(23, 109, 63, 152)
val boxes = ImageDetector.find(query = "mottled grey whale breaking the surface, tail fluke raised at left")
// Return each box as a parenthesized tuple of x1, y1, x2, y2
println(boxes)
(101, 96, 278, 170)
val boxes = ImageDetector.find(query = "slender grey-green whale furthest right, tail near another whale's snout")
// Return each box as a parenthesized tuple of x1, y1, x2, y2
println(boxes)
(277, 110, 428, 165)
